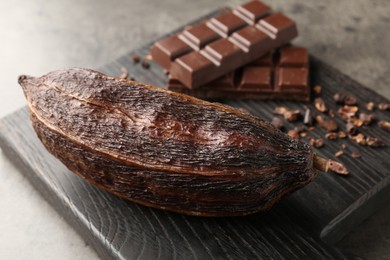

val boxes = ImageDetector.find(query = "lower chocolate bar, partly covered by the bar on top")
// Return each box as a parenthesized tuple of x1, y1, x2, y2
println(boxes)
(168, 46, 310, 101)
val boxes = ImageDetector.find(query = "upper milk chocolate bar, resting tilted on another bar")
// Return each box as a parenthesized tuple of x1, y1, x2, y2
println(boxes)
(151, 1, 298, 89)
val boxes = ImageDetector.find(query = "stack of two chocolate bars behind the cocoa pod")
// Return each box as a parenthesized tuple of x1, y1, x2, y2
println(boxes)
(151, 1, 310, 101)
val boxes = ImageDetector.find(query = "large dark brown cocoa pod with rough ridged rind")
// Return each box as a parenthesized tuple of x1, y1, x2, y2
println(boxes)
(19, 69, 315, 216)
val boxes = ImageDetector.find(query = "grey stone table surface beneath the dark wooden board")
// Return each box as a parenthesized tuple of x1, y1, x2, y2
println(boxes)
(0, 0, 390, 259)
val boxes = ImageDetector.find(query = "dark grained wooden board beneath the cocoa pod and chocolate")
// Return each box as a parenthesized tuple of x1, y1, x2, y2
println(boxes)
(0, 8, 390, 259)
